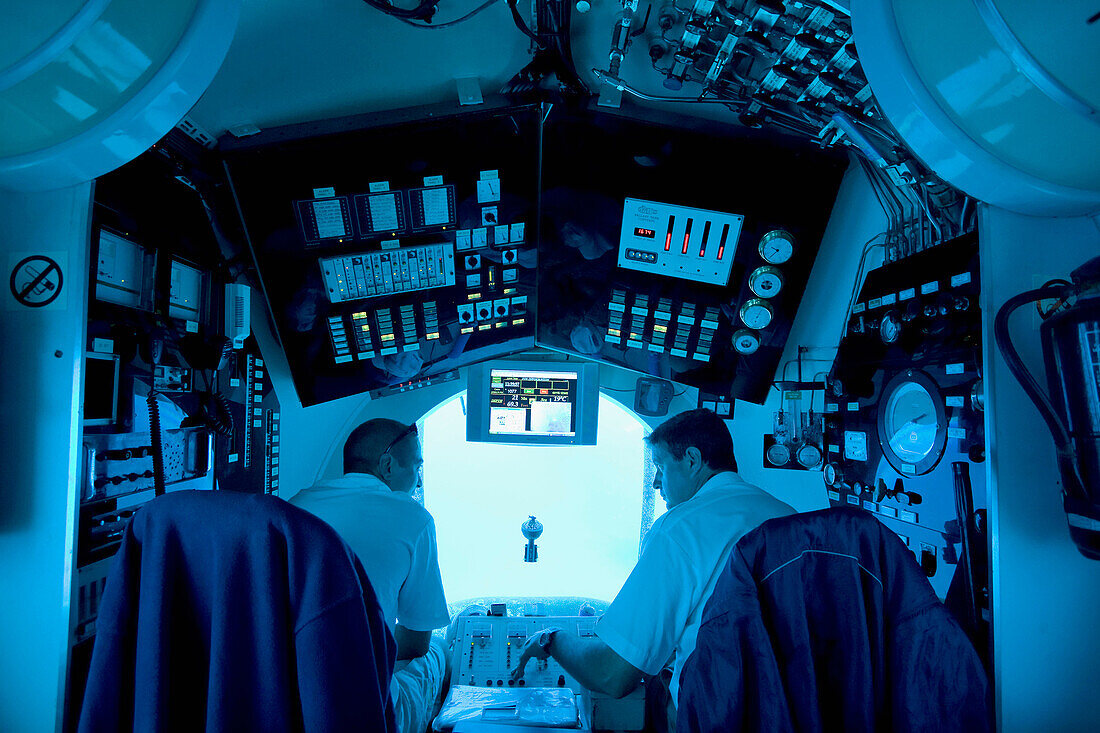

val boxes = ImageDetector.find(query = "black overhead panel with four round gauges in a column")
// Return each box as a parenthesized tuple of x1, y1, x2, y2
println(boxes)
(537, 111, 844, 404)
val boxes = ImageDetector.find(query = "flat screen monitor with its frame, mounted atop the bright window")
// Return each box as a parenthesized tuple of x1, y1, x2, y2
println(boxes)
(466, 360, 600, 446)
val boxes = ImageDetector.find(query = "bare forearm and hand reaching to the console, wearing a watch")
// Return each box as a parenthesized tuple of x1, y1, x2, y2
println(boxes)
(512, 632, 642, 698)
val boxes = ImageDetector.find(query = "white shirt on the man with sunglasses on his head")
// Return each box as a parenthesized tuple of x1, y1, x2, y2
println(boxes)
(290, 473, 450, 631)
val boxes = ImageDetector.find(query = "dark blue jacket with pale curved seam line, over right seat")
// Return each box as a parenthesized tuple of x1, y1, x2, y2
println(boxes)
(677, 507, 990, 733)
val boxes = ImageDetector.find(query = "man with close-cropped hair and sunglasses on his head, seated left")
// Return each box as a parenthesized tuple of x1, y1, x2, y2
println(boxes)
(290, 418, 450, 731)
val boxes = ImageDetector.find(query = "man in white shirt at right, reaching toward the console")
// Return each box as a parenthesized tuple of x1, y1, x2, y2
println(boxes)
(513, 409, 794, 721)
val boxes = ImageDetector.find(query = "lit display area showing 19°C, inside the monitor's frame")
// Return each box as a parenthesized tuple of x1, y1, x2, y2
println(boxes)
(488, 369, 579, 437)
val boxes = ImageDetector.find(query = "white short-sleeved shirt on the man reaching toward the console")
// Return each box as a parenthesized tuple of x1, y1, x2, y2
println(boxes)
(596, 471, 794, 701)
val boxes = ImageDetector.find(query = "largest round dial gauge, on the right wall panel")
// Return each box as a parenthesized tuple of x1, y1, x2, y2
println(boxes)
(878, 370, 947, 475)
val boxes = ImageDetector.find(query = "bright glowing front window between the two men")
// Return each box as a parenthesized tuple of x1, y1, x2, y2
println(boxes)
(422, 393, 664, 603)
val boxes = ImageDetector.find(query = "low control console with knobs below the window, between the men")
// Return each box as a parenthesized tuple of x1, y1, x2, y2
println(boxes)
(451, 616, 596, 692)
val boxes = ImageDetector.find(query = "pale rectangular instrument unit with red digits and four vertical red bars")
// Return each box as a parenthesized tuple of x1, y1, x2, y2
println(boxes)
(618, 198, 745, 286)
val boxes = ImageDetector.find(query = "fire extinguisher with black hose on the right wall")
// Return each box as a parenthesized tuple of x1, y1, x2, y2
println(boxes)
(993, 258, 1100, 560)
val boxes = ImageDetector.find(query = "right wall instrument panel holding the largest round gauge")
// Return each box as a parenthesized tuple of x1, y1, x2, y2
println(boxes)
(823, 236, 986, 597)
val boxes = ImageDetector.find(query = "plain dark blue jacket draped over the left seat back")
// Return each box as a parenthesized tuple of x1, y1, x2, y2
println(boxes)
(79, 491, 396, 733)
